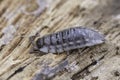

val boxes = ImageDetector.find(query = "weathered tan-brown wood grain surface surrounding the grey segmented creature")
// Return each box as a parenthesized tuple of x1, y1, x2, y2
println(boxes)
(0, 0, 120, 80)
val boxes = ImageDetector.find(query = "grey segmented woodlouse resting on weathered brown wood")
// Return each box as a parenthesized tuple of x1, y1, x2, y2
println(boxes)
(31, 27, 105, 53)
